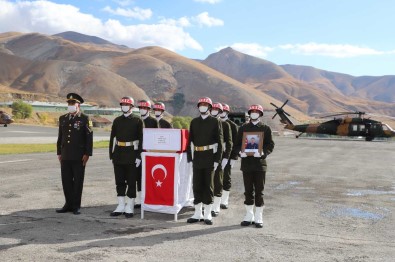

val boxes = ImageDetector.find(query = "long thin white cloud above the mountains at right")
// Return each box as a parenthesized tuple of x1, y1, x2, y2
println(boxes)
(279, 42, 386, 58)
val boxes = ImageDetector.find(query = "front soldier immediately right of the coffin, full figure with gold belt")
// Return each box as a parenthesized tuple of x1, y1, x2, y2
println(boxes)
(187, 97, 223, 225)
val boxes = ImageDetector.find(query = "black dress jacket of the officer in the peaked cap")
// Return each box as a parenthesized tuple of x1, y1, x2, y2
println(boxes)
(56, 112, 93, 161)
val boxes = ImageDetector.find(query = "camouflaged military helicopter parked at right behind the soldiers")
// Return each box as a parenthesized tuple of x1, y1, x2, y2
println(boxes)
(270, 100, 395, 141)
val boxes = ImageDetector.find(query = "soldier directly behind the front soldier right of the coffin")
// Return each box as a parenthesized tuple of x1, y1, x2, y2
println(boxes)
(211, 103, 233, 217)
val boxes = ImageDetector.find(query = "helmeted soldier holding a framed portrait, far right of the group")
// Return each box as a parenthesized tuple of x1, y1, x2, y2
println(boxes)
(235, 105, 274, 228)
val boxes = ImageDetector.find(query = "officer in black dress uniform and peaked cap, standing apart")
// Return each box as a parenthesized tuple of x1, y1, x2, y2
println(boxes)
(56, 93, 93, 215)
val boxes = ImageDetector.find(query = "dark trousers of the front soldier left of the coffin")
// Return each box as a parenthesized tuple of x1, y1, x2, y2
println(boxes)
(114, 163, 138, 198)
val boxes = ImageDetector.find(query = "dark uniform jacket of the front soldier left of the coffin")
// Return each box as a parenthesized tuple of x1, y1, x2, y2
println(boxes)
(109, 114, 144, 164)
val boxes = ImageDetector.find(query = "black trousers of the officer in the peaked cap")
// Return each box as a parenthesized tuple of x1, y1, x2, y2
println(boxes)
(60, 160, 85, 210)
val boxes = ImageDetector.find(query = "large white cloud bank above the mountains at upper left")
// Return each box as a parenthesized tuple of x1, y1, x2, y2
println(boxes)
(0, 0, 202, 51)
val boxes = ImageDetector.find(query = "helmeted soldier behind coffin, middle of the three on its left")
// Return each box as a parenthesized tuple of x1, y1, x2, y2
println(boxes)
(134, 100, 159, 208)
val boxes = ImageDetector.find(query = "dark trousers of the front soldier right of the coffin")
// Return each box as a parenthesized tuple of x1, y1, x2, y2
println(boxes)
(193, 167, 214, 205)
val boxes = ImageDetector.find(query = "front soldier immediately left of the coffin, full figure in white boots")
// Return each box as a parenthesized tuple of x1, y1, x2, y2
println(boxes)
(109, 96, 144, 218)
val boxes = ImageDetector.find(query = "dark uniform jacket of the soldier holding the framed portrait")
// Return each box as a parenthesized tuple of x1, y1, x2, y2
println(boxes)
(235, 122, 274, 172)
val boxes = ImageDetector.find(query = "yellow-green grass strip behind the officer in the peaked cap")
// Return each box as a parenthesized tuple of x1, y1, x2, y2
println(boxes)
(0, 141, 109, 155)
